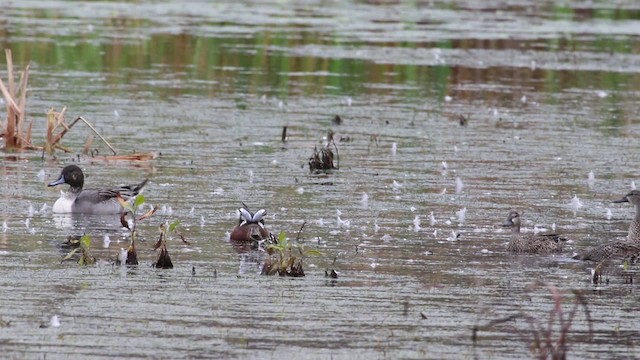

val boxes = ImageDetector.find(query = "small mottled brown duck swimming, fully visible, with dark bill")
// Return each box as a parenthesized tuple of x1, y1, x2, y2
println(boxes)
(502, 211, 567, 254)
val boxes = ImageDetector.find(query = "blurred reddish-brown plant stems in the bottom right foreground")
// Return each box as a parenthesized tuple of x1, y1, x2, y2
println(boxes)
(472, 282, 593, 359)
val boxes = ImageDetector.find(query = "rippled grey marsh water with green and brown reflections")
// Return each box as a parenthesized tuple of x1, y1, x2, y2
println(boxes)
(0, 1, 640, 359)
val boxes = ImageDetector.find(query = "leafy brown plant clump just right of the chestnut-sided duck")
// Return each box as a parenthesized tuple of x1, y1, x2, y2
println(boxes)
(261, 224, 322, 277)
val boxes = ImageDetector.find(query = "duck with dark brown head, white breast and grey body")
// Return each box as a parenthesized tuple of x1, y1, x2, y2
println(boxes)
(48, 165, 149, 215)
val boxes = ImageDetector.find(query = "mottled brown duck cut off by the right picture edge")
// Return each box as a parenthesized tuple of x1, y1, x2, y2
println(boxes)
(573, 190, 640, 263)
